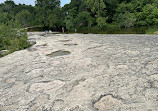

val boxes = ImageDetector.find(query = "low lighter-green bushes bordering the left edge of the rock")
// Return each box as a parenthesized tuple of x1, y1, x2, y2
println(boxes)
(0, 24, 30, 56)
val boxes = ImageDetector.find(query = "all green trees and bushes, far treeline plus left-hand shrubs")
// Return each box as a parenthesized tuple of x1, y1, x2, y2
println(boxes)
(0, 0, 158, 56)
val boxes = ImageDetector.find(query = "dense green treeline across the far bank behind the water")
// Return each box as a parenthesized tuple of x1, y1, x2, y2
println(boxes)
(0, 0, 158, 30)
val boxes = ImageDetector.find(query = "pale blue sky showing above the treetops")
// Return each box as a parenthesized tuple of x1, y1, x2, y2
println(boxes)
(0, 0, 71, 6)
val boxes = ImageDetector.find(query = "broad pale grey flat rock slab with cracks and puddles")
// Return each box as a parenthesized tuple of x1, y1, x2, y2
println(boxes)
(0, 33, 158, 111)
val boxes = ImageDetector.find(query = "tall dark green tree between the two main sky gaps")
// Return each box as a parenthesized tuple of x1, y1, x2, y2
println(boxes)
(35, 0, 61, 28)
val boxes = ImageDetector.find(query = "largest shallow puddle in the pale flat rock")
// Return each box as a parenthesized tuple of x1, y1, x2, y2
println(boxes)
(46, 50, 71, 57)
